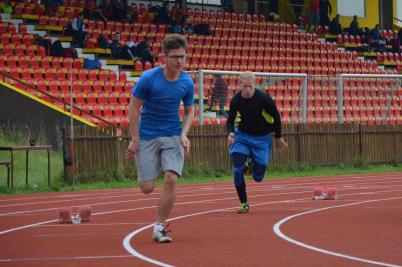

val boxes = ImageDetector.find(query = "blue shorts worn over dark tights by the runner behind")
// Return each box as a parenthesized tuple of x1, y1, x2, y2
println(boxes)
(229, 129, 272, 166)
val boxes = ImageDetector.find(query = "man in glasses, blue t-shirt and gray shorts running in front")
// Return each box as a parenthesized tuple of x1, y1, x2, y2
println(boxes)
(124, 34, 194, 243)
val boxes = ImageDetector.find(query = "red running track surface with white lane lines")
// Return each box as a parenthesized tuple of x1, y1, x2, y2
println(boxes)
(0, 173, 402, 267)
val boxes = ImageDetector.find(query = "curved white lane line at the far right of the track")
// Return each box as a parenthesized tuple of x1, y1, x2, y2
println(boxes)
(273, 197, 402, 267)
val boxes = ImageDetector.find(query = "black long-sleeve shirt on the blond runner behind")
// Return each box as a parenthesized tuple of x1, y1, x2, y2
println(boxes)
(226, 90, 282, 138)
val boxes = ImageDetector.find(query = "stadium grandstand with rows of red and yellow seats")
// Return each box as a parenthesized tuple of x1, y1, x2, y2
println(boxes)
(0, 0, 402, 130)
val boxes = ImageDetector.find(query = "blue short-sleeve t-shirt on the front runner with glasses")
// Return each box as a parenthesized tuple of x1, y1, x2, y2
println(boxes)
(131, 67, 194, 139)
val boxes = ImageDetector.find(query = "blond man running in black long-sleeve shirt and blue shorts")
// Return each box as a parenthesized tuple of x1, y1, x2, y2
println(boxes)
(226, 72, 288, 213)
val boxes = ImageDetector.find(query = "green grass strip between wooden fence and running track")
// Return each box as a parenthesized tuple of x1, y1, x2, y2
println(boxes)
(0, 129, 402, 194)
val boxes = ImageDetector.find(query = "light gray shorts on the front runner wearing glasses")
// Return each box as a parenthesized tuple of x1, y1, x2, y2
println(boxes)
(135, 136, 184, 182)
